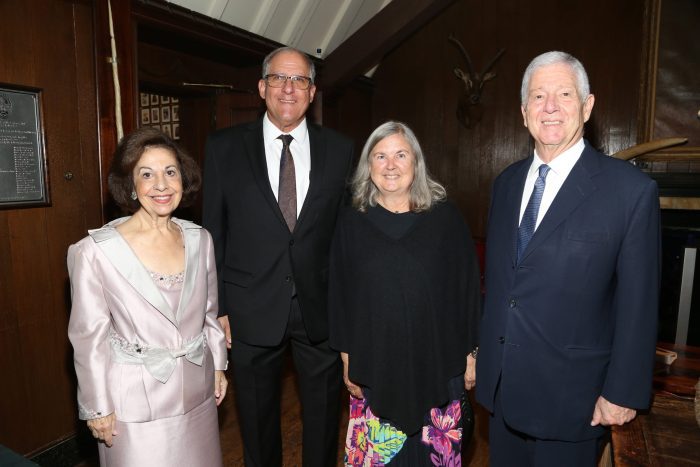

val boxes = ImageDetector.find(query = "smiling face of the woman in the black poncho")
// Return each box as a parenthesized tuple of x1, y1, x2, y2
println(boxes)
(369, 133, 416, 201)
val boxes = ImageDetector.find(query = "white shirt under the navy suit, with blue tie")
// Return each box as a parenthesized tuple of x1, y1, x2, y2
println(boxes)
(518, 138, 586, 230)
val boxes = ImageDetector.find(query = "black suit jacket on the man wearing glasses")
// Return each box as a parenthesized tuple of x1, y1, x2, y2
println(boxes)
(203, 119, 353, 346)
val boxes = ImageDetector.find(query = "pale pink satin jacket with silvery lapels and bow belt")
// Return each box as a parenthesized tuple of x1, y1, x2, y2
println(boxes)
(68, 218, 227, 422)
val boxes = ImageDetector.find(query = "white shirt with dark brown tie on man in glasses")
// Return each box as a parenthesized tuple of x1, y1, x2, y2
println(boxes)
(263, 112, 311, 217)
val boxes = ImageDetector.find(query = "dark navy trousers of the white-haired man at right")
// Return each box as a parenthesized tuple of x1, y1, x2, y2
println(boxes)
(489, 388, 600, 467)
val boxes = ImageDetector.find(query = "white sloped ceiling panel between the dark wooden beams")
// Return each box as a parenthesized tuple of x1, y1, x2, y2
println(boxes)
(167, 0, 391, 58)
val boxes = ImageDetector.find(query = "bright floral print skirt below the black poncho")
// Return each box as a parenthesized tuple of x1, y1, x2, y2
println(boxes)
(345, 380, 468, 467)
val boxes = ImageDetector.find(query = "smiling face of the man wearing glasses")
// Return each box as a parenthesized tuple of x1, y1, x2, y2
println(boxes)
(258, 51, 316, 133)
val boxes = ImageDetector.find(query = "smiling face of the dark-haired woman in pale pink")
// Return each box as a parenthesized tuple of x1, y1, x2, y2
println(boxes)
(133, 147, 182, 218)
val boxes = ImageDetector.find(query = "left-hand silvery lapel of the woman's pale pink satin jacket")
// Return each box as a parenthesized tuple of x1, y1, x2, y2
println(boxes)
(88, 218, 177, 326)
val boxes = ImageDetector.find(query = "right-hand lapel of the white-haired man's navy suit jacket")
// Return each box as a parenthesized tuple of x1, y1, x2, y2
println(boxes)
(522, 144, 599, 260)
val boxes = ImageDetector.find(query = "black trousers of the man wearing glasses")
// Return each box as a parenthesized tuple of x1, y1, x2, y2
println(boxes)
(230, 298, 342, 467)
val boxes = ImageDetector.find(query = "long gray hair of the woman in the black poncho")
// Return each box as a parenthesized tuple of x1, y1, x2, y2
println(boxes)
(351, 121, 447, 212)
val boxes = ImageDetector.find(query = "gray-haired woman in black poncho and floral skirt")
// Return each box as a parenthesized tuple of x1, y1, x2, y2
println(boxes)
(328, 122, 480, 466)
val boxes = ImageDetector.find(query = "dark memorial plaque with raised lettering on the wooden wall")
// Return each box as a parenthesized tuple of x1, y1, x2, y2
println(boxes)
(0, 84, 49, 208)
